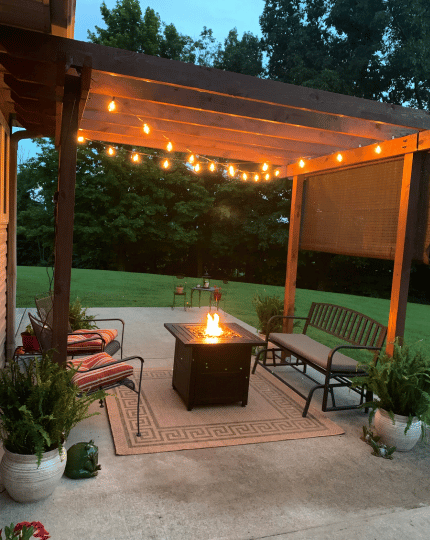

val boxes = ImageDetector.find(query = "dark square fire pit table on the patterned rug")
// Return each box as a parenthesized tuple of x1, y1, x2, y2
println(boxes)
(164, 323, 265, 411)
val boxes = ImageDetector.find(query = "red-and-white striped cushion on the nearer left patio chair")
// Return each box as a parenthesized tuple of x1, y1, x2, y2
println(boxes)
(68, 352, 133, 392)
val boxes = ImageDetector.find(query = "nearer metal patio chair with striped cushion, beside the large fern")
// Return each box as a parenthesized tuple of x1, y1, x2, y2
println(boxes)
(28, 313, 144, 437)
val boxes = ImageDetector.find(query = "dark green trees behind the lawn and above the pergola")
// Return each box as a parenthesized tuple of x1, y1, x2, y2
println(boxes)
(18, 0, 430, 301)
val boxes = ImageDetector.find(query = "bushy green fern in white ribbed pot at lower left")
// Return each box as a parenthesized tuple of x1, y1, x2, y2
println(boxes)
(0, 353, 106, 502)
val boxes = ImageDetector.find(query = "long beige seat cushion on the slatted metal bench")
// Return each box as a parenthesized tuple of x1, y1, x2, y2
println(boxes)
(269, 333, 358, 373)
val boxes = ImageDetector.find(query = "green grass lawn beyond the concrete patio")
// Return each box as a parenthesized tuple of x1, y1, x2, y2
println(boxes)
(16, 266, 430, 347)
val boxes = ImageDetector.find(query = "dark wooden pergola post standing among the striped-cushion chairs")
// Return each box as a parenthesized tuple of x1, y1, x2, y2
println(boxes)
(52, 75, 81, 364)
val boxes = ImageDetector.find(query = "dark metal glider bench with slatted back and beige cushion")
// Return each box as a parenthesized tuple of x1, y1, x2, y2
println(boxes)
(252, 302, 387, 416)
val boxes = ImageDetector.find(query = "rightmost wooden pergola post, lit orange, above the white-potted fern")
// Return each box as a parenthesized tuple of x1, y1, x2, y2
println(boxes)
(386, 152, 424, 355)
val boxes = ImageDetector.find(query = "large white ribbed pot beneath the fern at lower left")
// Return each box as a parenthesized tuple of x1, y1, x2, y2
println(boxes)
(0, 448, 67, 502)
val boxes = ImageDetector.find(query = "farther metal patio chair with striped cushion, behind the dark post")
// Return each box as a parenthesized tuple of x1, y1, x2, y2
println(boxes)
(35, 294, 125, 358)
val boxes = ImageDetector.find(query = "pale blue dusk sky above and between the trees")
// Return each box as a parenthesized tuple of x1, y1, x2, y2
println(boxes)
(18, 0, 264, 161)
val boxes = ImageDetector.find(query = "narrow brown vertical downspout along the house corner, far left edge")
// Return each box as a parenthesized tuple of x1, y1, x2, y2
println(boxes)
(6, 131, 40, 359)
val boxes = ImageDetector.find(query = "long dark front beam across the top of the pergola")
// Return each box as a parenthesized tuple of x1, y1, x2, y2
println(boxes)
(0, 25, 430, 129)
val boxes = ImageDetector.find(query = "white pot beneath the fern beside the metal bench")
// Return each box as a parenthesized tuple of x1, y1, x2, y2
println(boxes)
(374, 409, 421, 452)
